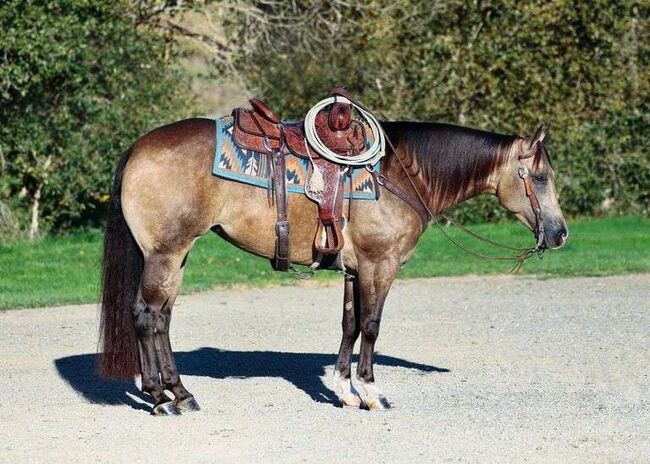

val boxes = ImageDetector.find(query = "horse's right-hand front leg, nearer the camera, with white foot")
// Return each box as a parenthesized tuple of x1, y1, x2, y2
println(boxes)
(357, 258, 399, 409)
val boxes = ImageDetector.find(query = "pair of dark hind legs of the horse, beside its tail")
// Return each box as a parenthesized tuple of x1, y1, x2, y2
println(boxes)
(133, 253, 198, 415)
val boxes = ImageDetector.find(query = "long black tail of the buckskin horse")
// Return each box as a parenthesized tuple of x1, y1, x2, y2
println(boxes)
(99, 149, 144, 378)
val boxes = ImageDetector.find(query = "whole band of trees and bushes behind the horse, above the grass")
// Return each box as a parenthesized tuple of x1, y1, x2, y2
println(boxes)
(0, 0, 650, 239)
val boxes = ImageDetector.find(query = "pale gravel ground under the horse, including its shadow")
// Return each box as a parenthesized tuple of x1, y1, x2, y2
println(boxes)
(0, 275, 650, 463)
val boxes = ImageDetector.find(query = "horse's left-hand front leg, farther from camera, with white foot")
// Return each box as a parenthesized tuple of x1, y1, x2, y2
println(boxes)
(334, 275, 362, 408)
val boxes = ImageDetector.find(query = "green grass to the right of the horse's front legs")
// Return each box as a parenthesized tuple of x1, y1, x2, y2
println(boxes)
(401, 217, 650, 277)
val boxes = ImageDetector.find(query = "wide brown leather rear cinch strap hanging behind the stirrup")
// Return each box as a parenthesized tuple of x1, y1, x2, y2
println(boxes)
(270, 149, 291, 271)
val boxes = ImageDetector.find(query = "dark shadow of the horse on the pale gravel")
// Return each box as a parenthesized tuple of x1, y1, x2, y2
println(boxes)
(54, 348, 449, 410)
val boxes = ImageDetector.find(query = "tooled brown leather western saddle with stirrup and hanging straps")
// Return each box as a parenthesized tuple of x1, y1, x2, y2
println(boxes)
(233, 87, 370, 271)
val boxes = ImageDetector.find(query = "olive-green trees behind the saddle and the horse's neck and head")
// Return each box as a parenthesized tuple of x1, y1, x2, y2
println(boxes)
(227, 0, 650, 220)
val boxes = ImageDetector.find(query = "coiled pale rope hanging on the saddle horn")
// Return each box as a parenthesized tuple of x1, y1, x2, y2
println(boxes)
(304, 95, 386, 166)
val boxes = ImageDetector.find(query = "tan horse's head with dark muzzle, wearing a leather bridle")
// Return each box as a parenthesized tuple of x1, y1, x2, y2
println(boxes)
(497, 121, 569, 248)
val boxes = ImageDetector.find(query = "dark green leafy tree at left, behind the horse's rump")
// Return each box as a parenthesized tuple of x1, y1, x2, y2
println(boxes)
(0, 0, 190, 232)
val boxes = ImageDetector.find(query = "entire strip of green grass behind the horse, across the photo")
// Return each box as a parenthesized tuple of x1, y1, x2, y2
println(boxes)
(0, 217, 650, 309)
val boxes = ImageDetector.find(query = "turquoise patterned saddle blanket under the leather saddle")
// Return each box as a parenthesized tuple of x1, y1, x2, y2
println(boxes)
(212, 116, 380, 200)
